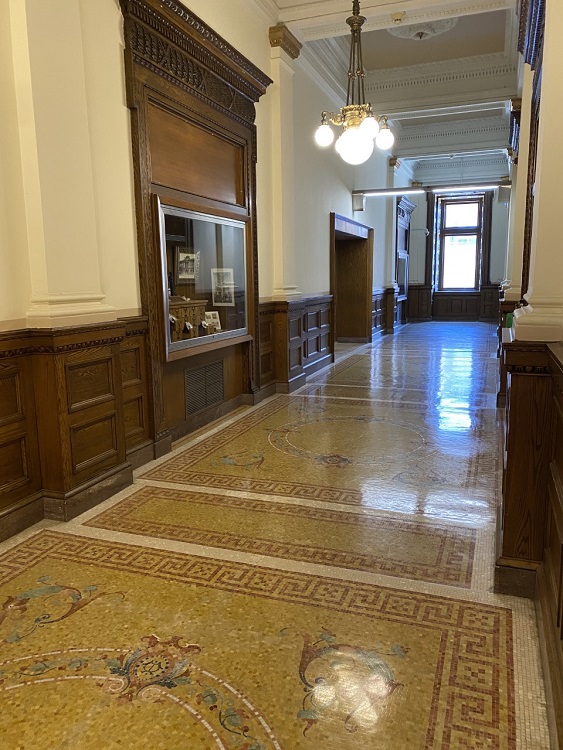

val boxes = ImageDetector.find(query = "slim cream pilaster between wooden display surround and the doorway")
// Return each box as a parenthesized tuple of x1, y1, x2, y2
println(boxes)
(268, 47, 301, 300)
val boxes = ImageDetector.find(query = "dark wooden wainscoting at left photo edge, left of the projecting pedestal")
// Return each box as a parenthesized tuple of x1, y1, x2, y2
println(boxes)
(0, 332, 43, 541)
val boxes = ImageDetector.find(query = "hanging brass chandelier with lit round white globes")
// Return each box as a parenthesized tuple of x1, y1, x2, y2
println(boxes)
(315, 0, 395, 164)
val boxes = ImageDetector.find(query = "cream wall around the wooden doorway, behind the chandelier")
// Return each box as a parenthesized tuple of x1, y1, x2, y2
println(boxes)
(293, 64, 392, 295)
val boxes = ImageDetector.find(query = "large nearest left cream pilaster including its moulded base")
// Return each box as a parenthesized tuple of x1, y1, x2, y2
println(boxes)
(21, 0, 115, 327)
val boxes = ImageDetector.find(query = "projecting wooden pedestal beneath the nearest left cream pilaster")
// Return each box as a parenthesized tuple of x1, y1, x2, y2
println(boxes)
(31, 322, 133, 521)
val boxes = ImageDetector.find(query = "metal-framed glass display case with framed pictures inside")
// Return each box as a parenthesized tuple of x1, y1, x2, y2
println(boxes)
(158, 202, 248, 353)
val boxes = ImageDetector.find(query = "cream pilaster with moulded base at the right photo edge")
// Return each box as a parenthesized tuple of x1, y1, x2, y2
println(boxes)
(514, 2, 563, 341)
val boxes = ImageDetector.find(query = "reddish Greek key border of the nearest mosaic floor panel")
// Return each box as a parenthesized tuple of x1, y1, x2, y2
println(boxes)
(0, 531, 516, 750)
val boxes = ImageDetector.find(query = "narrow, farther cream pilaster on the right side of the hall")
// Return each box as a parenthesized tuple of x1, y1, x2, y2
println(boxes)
(504, 64, 534, 302)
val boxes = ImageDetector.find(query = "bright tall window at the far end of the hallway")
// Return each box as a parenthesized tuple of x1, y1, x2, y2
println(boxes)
(436, 195, 484, 292)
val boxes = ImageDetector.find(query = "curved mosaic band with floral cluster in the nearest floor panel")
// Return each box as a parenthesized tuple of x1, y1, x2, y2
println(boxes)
(0, 635, 280, 750)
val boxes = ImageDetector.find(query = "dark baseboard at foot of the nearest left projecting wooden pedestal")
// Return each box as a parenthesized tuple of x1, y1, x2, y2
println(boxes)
(43, 463, 133, 521)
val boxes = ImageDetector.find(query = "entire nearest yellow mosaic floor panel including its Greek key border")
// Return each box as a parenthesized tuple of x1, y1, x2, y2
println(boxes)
(0, 531, 516, 750)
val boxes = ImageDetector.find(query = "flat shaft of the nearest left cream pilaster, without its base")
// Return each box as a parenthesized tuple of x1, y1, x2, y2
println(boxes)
(26, 0, 102, 295)
